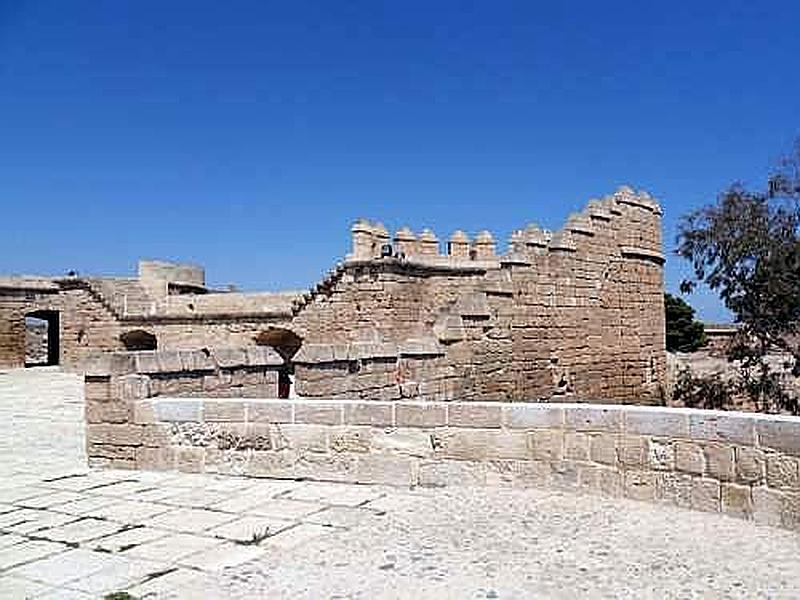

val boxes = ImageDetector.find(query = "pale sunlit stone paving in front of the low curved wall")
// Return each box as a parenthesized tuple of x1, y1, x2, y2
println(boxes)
(0, 370, 800, 600)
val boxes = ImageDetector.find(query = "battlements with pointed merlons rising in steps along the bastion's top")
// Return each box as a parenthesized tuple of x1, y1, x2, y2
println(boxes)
(347, 186, 663, 266)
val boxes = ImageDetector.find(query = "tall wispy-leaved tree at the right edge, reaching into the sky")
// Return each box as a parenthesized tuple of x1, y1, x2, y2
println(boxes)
(678, 142, 800, 413)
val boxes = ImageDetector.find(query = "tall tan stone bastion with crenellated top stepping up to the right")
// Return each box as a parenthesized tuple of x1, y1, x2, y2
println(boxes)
(290, 188, 666, 403)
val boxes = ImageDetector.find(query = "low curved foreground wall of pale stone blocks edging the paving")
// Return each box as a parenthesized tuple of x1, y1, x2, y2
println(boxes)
(86, 366, 800, 530)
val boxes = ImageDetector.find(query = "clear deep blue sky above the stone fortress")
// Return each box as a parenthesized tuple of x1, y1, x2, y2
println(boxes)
(0, 0, 800, 320)
